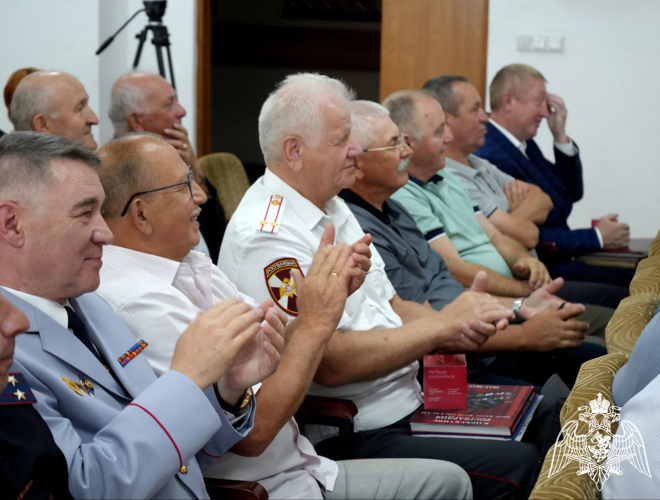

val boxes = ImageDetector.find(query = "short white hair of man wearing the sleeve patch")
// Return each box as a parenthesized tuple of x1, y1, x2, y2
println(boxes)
(259, 73, 355, 161)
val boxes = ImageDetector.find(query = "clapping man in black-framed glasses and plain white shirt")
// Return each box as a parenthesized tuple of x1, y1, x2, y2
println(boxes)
(99, 135, 471, 498)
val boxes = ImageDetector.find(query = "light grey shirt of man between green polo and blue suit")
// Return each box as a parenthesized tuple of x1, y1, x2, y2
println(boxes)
(445, 155, 515, 217)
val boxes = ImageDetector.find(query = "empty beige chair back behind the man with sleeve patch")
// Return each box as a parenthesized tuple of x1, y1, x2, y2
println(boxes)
(199, 153, 250, 220)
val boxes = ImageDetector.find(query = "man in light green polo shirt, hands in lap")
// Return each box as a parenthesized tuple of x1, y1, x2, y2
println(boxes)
(383, 90, 551, 297)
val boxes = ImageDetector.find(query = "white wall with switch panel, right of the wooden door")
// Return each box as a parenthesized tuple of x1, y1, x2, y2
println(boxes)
(487, 0, 660, 237)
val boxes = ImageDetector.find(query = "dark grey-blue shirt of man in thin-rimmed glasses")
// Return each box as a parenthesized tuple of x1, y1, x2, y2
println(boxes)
(341, 190, 465, 311)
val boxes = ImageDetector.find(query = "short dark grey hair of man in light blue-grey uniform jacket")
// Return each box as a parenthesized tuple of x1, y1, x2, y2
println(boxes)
(0, 132, 101, 198)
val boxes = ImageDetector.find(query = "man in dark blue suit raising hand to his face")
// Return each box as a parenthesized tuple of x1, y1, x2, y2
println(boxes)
(475, 64, 633, 286)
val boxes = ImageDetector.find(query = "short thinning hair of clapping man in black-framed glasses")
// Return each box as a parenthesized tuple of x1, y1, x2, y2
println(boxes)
(99, 132, 167, 218)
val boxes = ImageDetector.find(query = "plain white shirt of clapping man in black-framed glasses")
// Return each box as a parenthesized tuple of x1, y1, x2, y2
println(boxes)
(98, 246, 338, 498)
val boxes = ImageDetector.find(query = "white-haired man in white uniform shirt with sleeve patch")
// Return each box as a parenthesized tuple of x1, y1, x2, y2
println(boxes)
(219, 74, 538, 498)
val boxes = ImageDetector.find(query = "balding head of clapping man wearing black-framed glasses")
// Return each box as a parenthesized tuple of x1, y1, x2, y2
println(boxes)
(99, 133, 206, 261)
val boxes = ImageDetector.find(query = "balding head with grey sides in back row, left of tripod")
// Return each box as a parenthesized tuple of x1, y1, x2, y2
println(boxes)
(10, 71, 99, 151)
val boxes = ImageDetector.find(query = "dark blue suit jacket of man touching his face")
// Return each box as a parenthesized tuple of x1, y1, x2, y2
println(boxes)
(475, 123, 600, 260)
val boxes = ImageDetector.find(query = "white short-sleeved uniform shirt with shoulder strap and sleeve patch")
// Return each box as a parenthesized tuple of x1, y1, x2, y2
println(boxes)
(218, 169, 423, 431)
